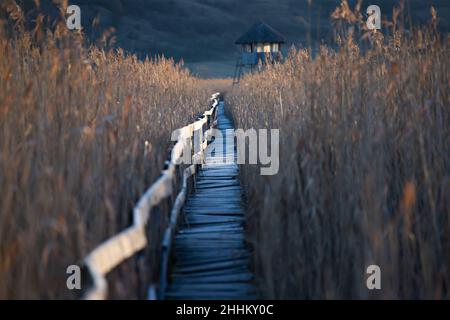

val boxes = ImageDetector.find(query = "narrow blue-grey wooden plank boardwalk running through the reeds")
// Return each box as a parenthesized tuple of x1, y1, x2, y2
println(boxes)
(165, 102, 256, 300)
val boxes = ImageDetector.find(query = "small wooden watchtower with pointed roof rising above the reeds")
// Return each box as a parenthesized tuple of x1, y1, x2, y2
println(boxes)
(233, 22, 285, 84)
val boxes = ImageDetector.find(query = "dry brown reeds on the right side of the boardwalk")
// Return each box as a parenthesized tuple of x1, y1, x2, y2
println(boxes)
(227, 18, 450, 299)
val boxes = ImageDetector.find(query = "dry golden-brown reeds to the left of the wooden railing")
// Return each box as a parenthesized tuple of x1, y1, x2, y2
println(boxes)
(0, 2, 209, 299)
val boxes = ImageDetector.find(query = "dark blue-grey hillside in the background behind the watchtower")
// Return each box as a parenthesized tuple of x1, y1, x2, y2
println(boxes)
(4, 0, 450, 73)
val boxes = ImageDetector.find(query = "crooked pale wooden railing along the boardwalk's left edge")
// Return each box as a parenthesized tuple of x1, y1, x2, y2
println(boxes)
(84, 93, 220, 300)
